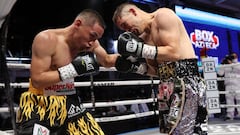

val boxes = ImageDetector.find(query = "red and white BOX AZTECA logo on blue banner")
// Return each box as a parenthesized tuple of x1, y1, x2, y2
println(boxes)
(190, 29, 219, 49)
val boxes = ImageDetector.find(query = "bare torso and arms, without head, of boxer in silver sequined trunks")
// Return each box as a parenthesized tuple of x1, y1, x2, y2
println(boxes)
(141, 8, 196, 75)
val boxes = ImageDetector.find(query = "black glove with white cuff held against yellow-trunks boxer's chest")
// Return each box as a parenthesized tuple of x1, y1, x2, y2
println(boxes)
(58, 52, 99, 81)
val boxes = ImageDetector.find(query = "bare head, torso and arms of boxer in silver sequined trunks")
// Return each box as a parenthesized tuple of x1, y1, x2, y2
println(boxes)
(115, 5, 196, 76)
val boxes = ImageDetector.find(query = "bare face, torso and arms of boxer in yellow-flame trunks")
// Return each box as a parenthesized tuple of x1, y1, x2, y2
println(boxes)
(30, 18, 118, 89)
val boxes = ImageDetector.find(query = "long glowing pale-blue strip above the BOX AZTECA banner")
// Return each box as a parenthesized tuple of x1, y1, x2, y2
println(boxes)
(175, 6, 240, 30)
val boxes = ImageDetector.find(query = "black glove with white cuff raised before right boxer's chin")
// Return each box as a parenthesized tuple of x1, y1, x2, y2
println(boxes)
(117, 32, 158, 59)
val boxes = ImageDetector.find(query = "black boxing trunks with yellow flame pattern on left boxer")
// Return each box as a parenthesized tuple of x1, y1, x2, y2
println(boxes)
(16, 79, 104, 135)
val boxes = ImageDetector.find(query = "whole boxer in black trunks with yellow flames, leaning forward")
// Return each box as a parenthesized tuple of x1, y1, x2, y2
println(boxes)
(16, 9, 119, 135)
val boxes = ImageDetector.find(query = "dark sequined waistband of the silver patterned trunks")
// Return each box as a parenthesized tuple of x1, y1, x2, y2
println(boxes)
(158, 58, 199, 80)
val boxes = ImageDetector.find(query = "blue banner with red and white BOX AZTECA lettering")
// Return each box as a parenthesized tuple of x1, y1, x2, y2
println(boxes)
(184, 21, 229, 63)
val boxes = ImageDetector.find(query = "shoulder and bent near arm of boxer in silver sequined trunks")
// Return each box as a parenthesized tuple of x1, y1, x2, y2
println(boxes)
(153, 12, 180, 62)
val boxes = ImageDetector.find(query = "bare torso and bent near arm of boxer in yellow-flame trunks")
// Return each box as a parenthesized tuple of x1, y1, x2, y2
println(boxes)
(31, 29, 92, 89)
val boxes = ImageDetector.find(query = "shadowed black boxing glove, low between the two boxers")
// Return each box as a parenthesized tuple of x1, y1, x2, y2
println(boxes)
(115, 56, 147, 75)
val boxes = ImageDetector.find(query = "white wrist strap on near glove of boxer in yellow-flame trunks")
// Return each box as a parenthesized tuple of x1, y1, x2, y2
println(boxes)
(58, 63, 78, 81)
